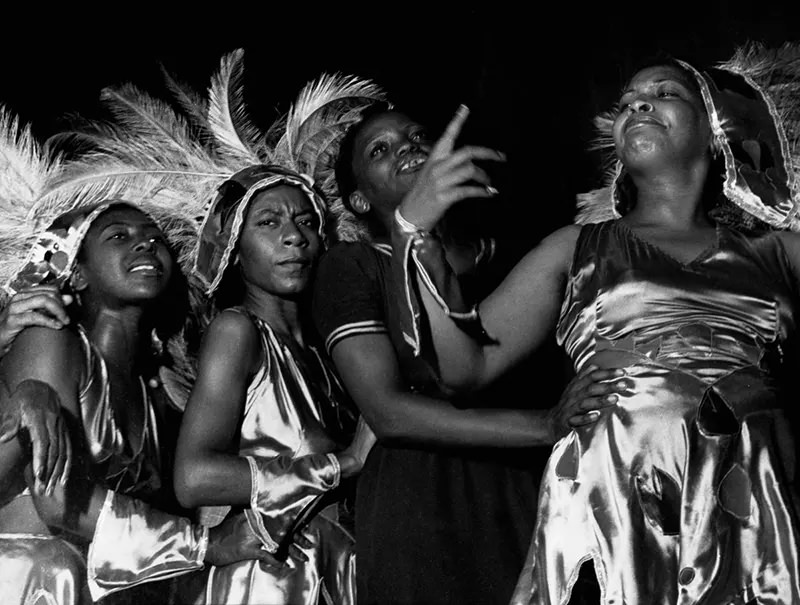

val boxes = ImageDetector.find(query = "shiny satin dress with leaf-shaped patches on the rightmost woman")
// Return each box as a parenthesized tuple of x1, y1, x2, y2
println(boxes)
(512, 221, 800, 605)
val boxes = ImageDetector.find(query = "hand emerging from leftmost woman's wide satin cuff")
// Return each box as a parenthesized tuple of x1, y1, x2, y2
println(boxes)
(205, 513, 311, 573)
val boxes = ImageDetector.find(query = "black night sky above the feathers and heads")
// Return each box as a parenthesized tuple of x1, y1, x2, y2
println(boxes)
(0, 0, 800, 248)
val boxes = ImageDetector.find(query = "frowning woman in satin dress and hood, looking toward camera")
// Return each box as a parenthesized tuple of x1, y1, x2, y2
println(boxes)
(175, 165, 374, 605)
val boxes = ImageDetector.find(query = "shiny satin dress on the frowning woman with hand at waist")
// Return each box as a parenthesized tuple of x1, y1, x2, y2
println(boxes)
(203, 309, 355, 605)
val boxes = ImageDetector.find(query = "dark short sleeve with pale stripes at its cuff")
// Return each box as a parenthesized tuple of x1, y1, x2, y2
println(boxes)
(312, 243, 388, 355)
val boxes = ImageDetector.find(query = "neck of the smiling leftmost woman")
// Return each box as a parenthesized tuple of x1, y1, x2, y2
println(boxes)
(81, 307, 151, 372)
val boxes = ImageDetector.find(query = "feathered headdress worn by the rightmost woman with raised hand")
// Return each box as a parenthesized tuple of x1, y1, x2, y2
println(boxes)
(575, 43, 800, 230)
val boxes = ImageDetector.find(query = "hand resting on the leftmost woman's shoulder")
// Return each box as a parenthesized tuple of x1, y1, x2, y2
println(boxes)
(0, 284, 72, 355)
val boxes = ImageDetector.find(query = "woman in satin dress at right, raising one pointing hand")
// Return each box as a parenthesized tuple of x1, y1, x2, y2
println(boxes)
(394, 47, 800, 605)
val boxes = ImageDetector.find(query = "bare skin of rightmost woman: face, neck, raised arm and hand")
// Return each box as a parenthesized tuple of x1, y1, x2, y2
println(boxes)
(400, 66, 800, 390)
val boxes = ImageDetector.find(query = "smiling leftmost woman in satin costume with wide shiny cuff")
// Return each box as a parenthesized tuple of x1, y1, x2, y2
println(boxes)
(0, 201, 271, 603)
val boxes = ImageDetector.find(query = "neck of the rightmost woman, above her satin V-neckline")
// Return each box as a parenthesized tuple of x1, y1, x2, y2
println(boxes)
(626, 163, 709, 229)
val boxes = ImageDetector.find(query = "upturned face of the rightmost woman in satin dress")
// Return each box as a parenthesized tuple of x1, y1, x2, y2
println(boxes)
(613, 65, 711, 169)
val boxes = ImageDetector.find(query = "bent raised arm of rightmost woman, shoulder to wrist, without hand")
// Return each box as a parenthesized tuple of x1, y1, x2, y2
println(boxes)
(392, 226, 578, 391)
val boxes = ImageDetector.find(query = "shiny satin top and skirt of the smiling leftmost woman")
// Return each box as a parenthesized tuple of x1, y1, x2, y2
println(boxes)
(0, 328, 173, 605)
